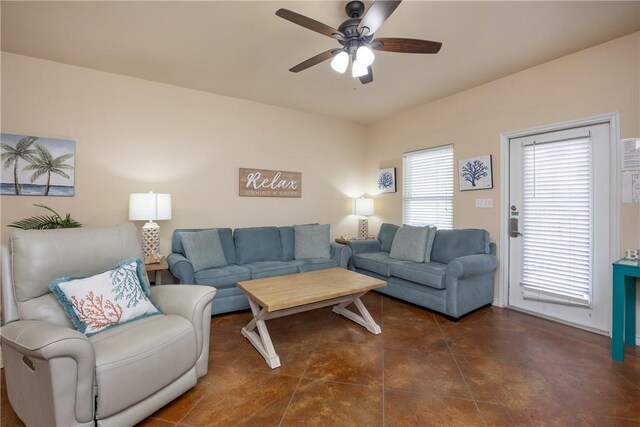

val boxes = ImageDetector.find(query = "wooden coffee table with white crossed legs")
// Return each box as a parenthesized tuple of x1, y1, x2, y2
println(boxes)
(238, 268, 387, 368)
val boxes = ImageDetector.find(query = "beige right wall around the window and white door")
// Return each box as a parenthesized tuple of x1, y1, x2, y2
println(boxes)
(366, 33, 640, 330)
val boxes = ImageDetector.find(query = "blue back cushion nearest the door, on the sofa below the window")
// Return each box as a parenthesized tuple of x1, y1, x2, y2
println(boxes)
(431, 228, 489, 264)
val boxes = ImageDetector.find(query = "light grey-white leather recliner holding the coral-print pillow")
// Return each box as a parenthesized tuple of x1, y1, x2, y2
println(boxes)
(2, 224, 216, 427)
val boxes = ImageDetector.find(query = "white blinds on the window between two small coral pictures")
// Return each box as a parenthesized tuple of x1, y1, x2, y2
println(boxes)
(402, 145, 453, 229)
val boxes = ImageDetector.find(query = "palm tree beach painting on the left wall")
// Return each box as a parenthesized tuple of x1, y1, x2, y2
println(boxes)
(0, 133, 76, 196)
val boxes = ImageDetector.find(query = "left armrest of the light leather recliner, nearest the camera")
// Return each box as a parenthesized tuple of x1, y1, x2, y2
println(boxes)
(2, 320, 96, 425)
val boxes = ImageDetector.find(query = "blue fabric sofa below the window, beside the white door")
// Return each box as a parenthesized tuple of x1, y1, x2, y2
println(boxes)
(348, 223, 498, 319)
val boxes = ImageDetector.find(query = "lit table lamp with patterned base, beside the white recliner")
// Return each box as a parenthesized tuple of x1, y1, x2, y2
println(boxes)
(129, 192, 171, 264)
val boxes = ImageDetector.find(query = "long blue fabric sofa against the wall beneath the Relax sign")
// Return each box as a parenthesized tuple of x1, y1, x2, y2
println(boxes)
(167, 226, 351, 314)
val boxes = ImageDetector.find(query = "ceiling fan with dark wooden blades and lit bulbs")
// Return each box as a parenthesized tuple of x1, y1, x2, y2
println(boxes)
(276, 0, 442, 84)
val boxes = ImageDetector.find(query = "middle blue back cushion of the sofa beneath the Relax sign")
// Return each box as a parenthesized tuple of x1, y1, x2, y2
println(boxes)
(233, 227, 282, 265)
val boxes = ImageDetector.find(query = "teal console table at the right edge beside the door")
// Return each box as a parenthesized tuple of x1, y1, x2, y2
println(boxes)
(611, 260, 640, 362)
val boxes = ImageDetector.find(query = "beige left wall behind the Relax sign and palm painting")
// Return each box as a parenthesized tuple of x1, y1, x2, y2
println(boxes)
(0, 53, 366, 254)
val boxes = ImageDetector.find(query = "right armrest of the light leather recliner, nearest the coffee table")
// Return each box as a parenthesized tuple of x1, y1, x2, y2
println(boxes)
(150, 285, 217, 377)
